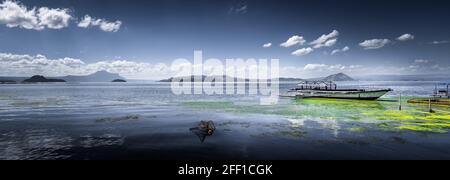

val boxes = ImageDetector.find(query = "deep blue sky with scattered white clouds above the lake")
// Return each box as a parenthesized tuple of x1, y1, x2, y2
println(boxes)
(0, 0, 450, 79)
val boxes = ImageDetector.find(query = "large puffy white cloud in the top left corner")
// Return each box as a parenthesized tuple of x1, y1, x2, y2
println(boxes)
(0, 0, 72, 30)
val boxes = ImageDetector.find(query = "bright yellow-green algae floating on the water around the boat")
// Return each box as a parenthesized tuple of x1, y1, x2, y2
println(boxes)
(182, 97, 450, 133)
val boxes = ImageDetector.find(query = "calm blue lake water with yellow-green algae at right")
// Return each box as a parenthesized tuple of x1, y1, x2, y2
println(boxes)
(0, 82, 450, 160)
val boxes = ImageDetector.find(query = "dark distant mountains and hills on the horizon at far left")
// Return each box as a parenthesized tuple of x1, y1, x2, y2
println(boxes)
(0, 71, 125, 83)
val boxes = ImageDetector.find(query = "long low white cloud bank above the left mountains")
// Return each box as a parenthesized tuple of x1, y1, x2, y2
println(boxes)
(0, 53, 174, 79)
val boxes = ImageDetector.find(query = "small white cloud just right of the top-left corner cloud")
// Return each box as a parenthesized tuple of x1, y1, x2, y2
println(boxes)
(78, 15, 122, 32)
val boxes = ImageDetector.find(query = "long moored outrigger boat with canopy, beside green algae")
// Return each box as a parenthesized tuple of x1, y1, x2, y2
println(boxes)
(284, 81, 392, 100)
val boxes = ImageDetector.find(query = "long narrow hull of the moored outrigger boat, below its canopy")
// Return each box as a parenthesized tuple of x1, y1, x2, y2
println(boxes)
(290, 89, 391, 100)
